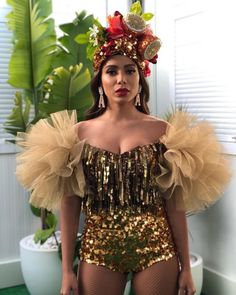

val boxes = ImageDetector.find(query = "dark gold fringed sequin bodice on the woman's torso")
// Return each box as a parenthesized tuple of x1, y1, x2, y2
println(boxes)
(82, 142, 164, 213)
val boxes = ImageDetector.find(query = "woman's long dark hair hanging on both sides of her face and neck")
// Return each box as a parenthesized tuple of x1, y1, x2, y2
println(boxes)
(85, 60, 150, 120)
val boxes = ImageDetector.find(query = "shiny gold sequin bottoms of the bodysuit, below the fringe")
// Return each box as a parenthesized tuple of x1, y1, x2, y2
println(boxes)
(80, 209, 176, 273)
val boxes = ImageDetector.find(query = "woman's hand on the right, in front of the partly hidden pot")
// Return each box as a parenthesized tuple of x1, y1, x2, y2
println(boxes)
(178, 270, 196, 295)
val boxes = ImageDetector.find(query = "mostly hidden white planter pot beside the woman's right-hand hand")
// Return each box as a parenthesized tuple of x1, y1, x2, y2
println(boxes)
(190, 253, 203, 295)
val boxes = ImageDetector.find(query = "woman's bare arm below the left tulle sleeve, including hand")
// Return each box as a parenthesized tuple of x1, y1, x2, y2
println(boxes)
(60, 196, 81, 295)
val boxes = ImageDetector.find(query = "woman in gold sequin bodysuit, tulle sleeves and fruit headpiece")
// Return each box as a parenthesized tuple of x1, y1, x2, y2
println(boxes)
(17, 5, 228, 295)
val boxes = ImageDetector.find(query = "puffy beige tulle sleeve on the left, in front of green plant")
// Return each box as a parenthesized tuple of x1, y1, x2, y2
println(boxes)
(16, 110, 85, 210)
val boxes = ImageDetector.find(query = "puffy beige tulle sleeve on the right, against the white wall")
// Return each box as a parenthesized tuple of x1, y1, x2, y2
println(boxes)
(157, 112, 231, 214)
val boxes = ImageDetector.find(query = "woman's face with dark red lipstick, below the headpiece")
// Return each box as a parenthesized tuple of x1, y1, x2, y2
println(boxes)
(101, 55, 139, 103)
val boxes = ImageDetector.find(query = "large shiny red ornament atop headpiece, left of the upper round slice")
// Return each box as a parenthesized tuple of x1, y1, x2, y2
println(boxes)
(107, 11, 125, 39)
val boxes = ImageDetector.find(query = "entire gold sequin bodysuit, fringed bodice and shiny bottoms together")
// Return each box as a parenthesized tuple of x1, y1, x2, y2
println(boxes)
(80, 142, 176, 273)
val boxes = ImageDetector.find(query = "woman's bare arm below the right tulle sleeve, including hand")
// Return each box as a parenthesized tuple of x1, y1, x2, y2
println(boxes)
(166, 198, 196, 295)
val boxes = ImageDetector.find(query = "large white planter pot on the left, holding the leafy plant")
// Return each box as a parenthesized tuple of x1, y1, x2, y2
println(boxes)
(20, 235, 62, 295)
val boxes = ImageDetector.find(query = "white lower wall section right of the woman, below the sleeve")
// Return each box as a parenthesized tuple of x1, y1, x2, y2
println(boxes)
(189, 156, 236, 295)
